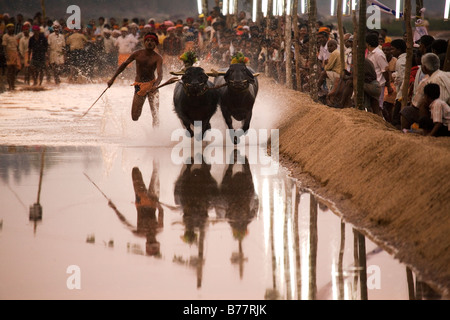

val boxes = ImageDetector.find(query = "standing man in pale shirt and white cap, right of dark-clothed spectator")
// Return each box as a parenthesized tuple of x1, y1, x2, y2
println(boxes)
(47, 21, 66, 84)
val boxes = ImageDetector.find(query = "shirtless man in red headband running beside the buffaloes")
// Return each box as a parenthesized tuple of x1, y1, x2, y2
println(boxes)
(108, 33, 163, 127)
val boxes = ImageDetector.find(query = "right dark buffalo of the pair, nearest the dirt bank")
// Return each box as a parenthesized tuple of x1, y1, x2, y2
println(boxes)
(214, 63, 258, 141)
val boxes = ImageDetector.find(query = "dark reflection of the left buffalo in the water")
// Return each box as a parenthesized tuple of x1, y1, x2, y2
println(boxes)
(174, 160, 219, 243)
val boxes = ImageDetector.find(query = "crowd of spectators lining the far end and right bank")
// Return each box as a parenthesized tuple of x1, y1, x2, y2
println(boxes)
(0, 7, 450, 135)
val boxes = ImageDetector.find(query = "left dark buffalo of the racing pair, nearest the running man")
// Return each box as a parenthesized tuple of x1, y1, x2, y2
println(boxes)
(173, 67, 219, 137)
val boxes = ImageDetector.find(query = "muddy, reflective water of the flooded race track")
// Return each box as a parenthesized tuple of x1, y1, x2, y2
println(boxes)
(0, 83, 436, 300)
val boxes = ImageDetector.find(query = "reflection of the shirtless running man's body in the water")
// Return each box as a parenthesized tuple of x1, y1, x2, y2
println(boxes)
(132, 162, 164, 255)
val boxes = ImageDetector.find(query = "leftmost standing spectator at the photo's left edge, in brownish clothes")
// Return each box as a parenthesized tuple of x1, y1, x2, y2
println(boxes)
(2, 23, 21, 90)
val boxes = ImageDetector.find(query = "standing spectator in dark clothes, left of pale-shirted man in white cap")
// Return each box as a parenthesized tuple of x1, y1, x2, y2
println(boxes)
(28, 25, 48, 86)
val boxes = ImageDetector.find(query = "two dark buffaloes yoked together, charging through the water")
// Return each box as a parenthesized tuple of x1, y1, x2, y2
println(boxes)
(173, 63, 258, 143)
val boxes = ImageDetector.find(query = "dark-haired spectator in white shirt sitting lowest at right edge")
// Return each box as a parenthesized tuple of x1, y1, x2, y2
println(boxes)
(419, 83, 450, 137)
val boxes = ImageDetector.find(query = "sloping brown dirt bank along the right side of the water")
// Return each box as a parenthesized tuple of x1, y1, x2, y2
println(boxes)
(268, 79, 450, 298)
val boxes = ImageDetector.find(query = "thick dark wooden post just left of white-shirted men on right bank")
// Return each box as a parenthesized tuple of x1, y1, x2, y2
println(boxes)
(356, 1, 367, 110)
